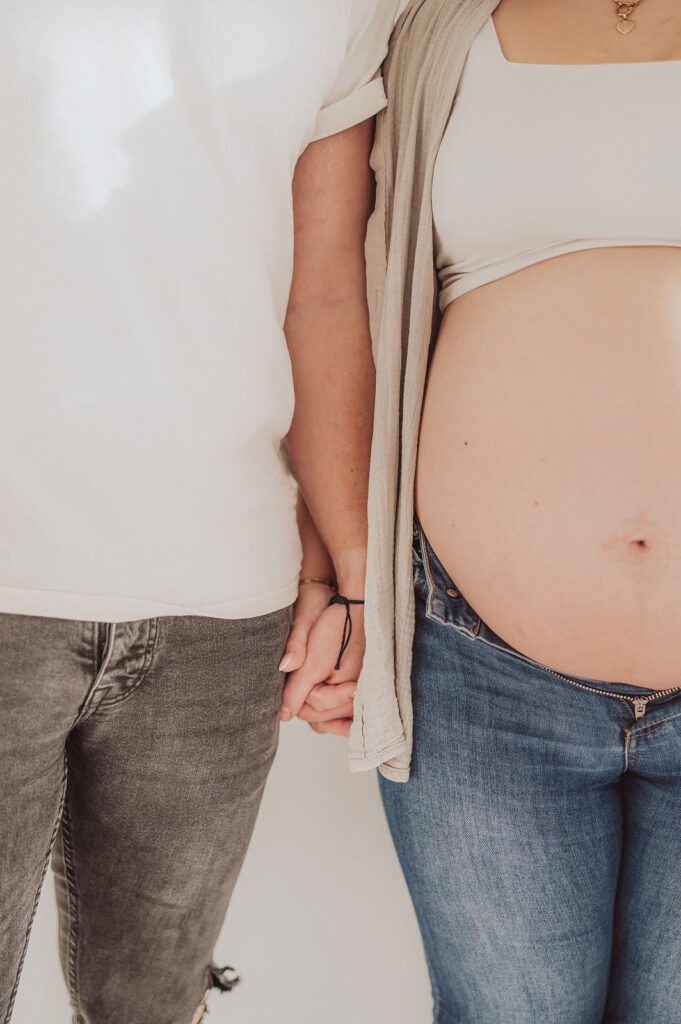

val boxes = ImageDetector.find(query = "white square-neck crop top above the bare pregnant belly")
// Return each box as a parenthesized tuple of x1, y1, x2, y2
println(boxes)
(433, 18, 681, 309)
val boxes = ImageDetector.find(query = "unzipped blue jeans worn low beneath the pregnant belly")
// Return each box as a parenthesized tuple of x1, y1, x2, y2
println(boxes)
(381, 529, 681, 1024)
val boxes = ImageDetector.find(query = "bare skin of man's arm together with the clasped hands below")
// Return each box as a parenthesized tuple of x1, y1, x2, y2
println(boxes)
(281, 119, 375, 735)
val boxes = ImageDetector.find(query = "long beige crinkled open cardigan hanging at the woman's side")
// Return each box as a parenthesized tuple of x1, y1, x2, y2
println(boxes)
(349, 0, 499, 781)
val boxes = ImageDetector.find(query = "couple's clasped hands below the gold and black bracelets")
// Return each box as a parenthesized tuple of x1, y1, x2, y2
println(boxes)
(280, 597, 365, 736)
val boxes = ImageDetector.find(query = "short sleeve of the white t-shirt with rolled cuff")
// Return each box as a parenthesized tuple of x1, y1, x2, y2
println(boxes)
(312, 0, 409, 141)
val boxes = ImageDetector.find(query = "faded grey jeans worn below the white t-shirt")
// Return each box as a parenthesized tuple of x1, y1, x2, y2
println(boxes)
(0, 608, 291, 1024)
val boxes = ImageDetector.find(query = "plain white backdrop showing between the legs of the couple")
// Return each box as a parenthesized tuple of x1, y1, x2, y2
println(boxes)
(12, 722, 432, 1024)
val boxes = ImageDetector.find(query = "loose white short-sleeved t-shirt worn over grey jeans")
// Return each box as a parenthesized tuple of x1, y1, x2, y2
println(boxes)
(0, 0, 401, 622)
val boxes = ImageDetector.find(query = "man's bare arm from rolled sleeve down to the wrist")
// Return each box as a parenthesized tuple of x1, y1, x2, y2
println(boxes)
(286, 121, 374, 596)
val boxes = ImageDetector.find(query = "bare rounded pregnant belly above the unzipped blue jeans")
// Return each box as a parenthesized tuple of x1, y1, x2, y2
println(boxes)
(416, 248, 681, 688)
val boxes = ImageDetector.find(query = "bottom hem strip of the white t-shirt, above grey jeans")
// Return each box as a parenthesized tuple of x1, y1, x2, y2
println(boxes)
(0, 578, 298, 623)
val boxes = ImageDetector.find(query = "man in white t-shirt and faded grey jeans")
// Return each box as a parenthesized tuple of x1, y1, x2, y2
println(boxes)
(0, 0, 401, 1024)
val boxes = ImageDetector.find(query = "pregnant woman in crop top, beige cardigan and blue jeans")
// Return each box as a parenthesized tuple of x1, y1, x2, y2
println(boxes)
(358, 0, 681, 1024)
